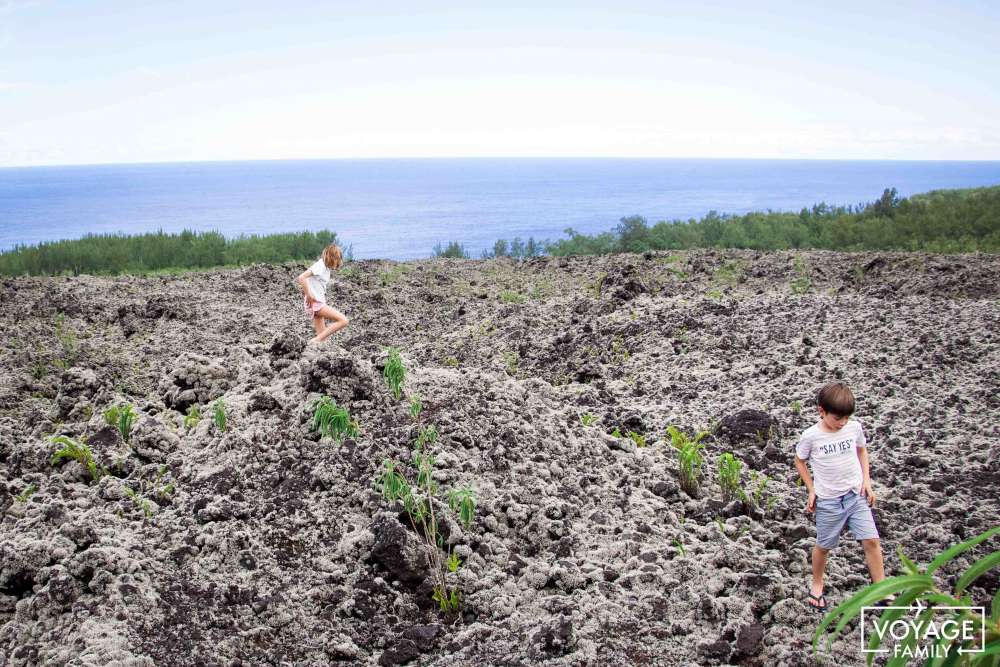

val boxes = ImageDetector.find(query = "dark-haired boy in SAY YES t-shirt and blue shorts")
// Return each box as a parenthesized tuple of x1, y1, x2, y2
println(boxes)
(795, 382, 885, 613)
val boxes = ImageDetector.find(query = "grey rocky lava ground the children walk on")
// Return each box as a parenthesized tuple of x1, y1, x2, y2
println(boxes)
(0, 251, 1000, 666)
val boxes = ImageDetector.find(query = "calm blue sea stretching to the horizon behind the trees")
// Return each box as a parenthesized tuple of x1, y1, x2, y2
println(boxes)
(0, 159, 1000, 259)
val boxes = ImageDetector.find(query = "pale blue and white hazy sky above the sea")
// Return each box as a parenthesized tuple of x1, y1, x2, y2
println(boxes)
(0, 0, 1000, 166)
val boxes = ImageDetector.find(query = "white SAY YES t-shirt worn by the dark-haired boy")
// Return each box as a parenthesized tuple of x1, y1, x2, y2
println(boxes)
(795, 420, 868, 498)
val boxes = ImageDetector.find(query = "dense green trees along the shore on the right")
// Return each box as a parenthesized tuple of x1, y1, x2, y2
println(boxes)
(487, 186, 1000, 256)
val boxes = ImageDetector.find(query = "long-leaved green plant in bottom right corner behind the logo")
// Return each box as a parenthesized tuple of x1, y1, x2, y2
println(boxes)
(813, 526, 1000, 667)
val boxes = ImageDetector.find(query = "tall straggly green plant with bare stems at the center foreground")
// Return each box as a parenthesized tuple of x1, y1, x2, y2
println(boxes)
(375, 426, 476, 613)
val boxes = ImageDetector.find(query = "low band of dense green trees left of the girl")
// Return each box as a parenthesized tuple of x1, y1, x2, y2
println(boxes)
(0, 229, 350, 276)
